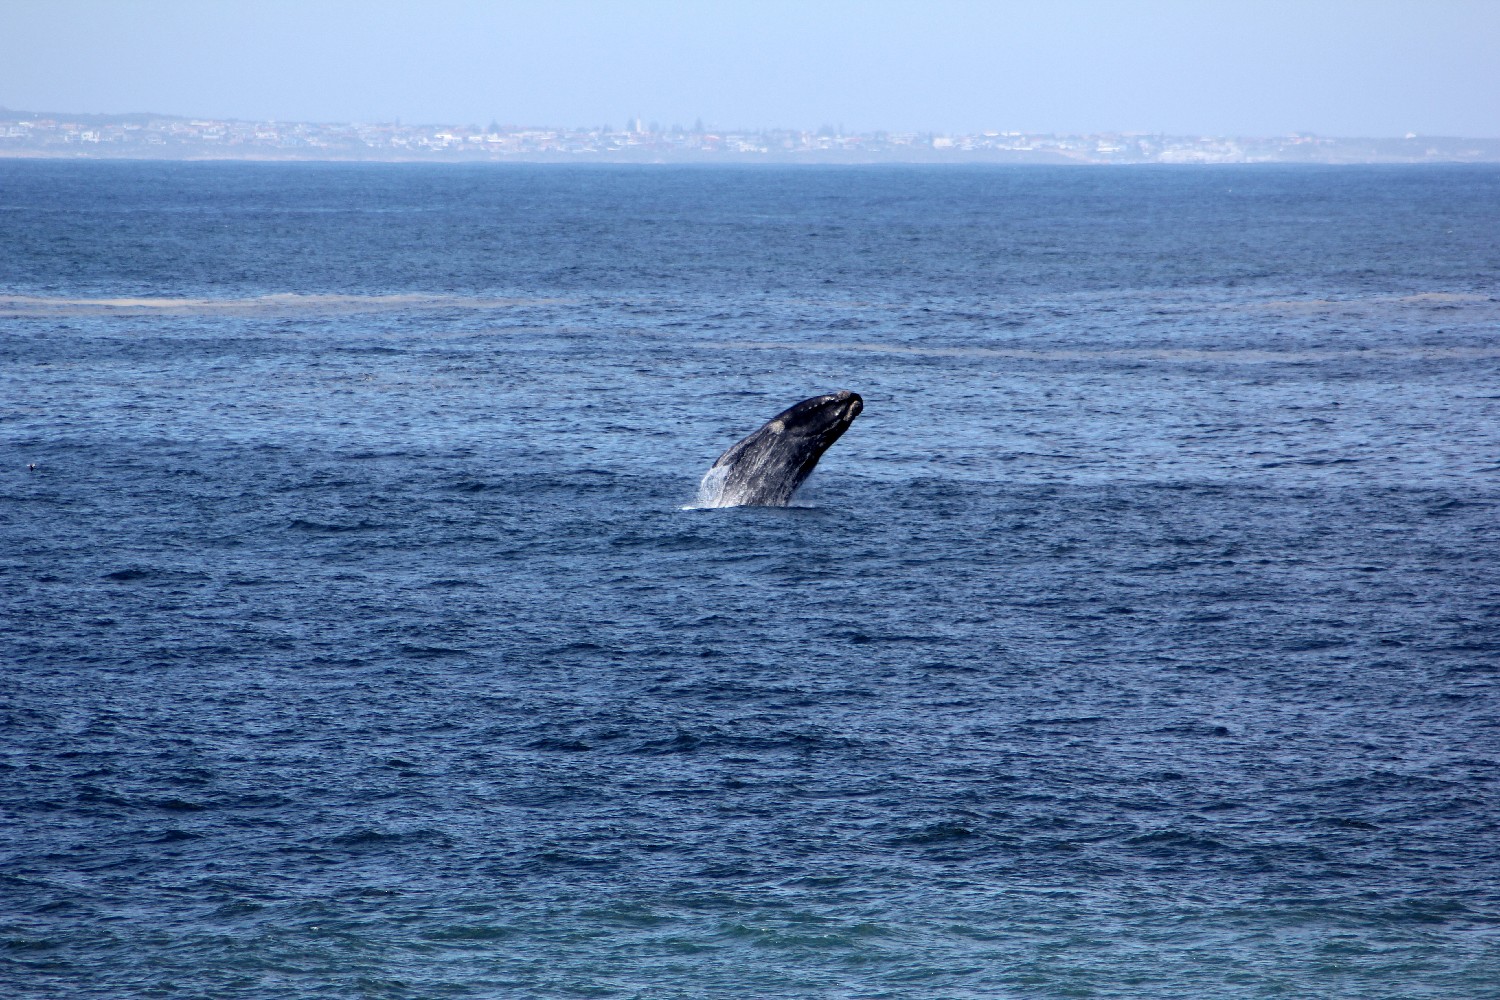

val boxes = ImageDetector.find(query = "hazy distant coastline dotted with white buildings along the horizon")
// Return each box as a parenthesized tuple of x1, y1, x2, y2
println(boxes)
(0, 108, 1500, 163)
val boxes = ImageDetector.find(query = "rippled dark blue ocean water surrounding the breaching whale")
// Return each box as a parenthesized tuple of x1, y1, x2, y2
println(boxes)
(0, 162, 1500, 999)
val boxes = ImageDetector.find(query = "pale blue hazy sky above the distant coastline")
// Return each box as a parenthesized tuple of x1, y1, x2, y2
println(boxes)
(0, 0, 1500, 136)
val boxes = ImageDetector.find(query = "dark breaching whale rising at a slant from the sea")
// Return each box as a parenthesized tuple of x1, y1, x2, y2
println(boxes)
(699, 390, 864, 507)
